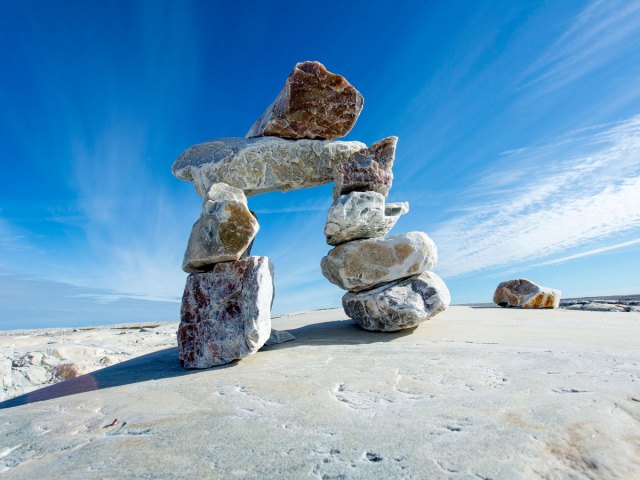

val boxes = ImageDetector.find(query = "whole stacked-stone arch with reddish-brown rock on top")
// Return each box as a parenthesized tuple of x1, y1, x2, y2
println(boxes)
(172, 62, 450, 368)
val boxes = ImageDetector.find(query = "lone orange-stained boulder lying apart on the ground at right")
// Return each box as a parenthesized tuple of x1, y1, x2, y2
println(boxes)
(493, 278, 561, 308)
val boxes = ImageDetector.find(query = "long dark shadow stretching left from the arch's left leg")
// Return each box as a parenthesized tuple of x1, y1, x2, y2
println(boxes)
(0, 347, 236, 409)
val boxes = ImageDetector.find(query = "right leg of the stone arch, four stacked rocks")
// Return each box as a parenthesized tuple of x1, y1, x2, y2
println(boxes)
(321, 137, 451, 332)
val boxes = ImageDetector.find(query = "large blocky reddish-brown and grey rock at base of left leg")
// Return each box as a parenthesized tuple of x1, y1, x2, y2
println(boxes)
(178, 257, 273, 368)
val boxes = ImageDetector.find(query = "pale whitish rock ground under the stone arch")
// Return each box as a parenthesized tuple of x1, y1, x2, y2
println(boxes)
(0, 307, 640, 479)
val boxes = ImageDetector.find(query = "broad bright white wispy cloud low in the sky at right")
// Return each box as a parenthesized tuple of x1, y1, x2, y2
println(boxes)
(433, 116, 640, 277)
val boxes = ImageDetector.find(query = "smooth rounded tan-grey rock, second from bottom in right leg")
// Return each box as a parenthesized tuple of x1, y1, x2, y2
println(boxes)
(320, 232, 438, 292)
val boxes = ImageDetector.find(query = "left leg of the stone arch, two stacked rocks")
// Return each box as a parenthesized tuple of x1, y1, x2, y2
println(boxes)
(178, 183, 274, 368)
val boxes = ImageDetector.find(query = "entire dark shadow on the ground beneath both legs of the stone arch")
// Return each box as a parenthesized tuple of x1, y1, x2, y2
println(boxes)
(0, 320, 414, 409)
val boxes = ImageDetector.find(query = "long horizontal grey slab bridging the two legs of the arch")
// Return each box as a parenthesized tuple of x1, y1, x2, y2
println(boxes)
(172, 137, 367, 197)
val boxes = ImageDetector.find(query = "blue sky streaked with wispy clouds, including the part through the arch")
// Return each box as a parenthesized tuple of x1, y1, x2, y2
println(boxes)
(0, 0, 640, 329)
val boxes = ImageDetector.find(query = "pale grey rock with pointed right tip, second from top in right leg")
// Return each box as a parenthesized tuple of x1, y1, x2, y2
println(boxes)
(324, 192, 409, 245)
